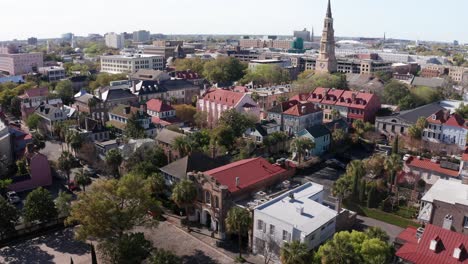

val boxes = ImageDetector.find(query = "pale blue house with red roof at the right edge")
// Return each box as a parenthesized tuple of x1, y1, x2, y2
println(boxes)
(423, 110, 468, 149)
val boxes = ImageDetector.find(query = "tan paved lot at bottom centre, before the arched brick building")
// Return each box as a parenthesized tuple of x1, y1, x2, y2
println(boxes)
(136, 222, 234, 264)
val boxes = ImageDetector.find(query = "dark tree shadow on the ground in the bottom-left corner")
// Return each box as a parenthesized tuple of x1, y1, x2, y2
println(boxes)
(0, 241, 55, 264)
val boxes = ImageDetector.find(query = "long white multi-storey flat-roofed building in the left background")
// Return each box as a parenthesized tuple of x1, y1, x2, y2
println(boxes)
(101, 54, 164, 74)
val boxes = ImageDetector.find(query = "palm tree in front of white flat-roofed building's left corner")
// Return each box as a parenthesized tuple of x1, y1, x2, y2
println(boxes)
(225, 206, 252, 260)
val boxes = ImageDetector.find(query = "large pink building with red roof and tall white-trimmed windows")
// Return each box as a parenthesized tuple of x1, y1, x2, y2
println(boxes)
(197, 89, 260, 127)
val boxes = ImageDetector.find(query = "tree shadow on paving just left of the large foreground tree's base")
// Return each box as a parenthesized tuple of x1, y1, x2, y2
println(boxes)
(41, 228, 91, 255)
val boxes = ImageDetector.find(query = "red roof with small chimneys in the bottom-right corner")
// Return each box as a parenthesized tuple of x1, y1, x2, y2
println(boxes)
(396, 224, 468, 264)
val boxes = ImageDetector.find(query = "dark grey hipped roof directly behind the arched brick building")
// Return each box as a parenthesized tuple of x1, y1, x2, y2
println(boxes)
(160, 152, 224, 179)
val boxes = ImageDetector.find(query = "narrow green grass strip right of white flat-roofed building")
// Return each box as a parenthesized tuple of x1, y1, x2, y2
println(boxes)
(344, 201, 419, 228)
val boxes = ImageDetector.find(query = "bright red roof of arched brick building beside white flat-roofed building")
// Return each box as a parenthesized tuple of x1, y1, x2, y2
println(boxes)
(204, 158, 286, 193)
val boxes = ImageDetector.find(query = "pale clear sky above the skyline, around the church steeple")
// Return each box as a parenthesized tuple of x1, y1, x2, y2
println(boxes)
(0, 0, 468, 43)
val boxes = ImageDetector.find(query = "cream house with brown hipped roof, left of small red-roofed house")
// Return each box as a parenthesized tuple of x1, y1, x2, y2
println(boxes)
(107, 104, 156, 137)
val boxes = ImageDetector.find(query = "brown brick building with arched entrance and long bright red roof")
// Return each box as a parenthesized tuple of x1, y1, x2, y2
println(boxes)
(188, 158, 295, 238)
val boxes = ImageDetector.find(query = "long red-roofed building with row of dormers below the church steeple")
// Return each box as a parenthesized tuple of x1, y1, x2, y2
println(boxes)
(308, 87, 381, 123)
